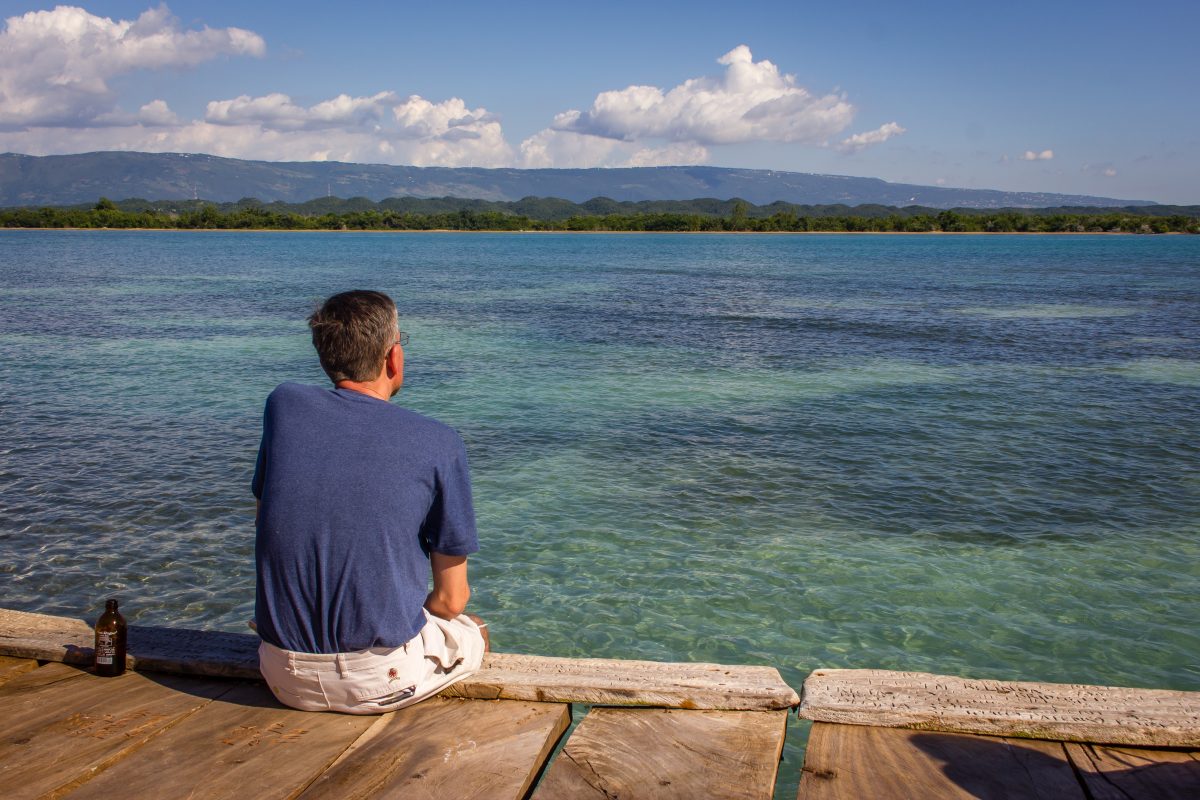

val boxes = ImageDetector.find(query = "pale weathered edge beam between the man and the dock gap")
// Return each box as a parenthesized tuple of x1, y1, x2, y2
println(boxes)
(443, 652, 799, 711)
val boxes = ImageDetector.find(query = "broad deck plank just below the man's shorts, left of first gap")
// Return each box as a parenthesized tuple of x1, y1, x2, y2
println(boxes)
(301, 698, 570, 800)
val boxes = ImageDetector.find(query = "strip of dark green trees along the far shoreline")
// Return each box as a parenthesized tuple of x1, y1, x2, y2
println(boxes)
(0, 197, 1200, 234)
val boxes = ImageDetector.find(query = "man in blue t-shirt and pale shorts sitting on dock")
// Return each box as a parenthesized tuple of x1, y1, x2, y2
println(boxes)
(252, 290, 487, 714)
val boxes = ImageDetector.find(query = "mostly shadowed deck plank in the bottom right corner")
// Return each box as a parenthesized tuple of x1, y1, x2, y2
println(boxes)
(1066, 744, 1200, 800)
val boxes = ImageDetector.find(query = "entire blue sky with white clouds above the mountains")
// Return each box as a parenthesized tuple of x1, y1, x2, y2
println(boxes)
(0, 0, 1200, 203)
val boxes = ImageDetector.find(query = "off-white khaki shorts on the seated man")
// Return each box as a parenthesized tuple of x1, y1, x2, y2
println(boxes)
(258, 612, 484, 714)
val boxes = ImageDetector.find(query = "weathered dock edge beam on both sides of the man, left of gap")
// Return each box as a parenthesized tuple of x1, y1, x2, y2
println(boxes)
(0, 608, 800, 711)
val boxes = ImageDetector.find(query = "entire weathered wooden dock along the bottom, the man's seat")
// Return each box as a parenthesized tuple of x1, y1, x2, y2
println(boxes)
(0, 609, 1200, 800)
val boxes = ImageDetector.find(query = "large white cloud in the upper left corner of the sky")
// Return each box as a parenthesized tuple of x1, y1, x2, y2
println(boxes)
(0, 6, 266, 130)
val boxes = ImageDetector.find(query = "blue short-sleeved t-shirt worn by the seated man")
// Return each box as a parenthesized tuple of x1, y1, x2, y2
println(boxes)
(252, 384, 479, 652)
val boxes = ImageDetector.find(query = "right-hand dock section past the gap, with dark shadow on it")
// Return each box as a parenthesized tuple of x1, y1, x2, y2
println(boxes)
(799, 669, 1200, 800)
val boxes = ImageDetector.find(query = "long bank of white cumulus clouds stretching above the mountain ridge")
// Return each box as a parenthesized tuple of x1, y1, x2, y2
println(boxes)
(0, 20, 904, 168)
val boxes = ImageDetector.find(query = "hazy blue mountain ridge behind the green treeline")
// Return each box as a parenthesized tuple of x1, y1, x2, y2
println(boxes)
(0, 151, 1153, 209)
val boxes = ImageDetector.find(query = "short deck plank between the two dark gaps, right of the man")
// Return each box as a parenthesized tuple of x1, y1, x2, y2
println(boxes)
(533, 709, 787, 800)
